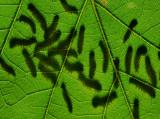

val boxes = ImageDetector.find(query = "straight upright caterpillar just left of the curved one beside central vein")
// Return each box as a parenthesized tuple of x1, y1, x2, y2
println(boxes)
(89, 51, 96, 79)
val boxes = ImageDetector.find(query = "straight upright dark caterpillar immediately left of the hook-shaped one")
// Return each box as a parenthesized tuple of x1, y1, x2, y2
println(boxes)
(125, 46, 133, 73)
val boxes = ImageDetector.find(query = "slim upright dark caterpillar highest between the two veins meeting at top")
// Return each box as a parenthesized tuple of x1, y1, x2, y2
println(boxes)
(78, 25, 85, 54)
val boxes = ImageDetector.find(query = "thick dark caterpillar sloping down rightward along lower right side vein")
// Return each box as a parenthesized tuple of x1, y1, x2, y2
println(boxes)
(129, 78, 156, 98)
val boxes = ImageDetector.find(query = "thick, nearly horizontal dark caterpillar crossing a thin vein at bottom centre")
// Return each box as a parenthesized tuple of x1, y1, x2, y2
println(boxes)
(92, 91, 117, 107)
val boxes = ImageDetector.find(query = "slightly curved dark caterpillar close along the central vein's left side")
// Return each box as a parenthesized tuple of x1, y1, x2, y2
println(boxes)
(99, 41, 109, 73)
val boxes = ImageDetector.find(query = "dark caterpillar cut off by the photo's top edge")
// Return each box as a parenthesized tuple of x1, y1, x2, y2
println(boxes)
(60, 0, 78, 14)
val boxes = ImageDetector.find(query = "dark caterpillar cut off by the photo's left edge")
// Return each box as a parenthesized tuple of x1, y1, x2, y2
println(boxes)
(0, 57, 16, 76)
